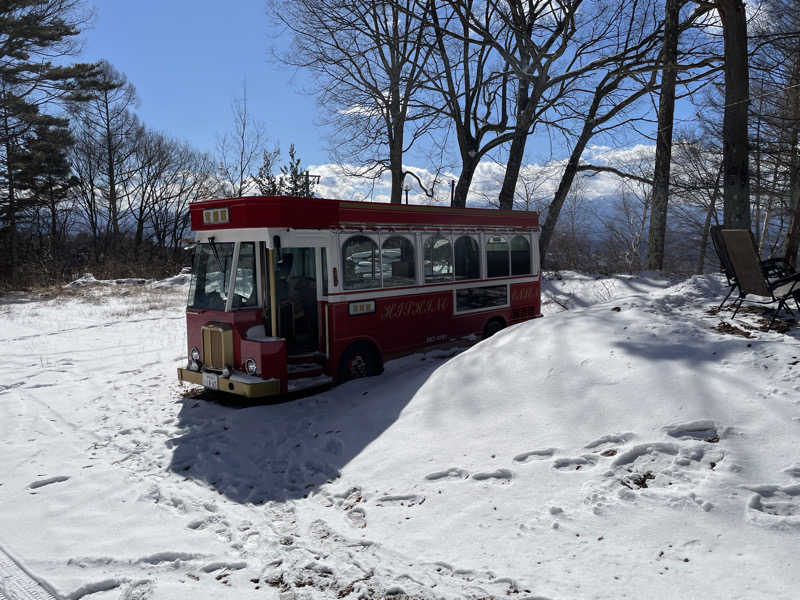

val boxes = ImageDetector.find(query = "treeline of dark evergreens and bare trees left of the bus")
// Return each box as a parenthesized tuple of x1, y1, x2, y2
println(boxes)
(0, 0, 313, 287)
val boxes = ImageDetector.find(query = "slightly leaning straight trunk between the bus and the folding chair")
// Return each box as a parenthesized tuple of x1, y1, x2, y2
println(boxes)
(645, 0, 681, 271)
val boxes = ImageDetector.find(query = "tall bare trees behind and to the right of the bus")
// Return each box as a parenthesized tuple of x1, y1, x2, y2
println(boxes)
(268, 0, 800, 271)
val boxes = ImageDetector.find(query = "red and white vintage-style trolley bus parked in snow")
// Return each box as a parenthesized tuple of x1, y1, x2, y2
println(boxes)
(178, 196, 541, 397)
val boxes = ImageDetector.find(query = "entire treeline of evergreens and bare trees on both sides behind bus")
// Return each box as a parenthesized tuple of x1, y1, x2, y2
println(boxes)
(0, 0, 800, 286)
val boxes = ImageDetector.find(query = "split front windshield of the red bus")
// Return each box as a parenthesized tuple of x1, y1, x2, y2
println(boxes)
(189, 242, 258, 310)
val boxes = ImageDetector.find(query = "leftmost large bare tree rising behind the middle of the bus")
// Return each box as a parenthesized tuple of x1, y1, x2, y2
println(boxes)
(269, 0, 434, 204)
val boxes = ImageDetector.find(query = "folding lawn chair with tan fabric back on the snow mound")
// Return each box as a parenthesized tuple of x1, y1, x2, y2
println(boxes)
(721, 229, 800, 331)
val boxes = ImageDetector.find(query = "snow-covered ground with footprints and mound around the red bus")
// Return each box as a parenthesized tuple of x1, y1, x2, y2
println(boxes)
(0, 273, 800, 600)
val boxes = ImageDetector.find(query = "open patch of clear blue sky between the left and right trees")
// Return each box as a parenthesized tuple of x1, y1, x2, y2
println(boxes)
(82, 0, 328, 163)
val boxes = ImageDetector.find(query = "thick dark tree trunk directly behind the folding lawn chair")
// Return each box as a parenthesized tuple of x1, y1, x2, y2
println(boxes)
(717, 0, 750, 231)
